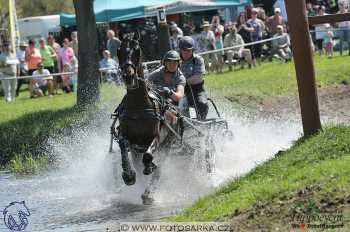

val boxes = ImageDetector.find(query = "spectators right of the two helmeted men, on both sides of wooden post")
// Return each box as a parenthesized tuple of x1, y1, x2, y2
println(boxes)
(170, 0, 350, 70)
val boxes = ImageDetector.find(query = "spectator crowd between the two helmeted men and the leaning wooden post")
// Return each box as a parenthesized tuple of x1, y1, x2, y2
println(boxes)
(170, 7, 292, 73)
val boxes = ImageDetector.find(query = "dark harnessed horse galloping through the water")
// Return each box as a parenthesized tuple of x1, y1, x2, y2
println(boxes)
(110, 33, 181, 204)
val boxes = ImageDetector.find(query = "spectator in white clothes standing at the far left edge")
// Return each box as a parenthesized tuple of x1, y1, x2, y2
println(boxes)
(0, 43, 19, 102)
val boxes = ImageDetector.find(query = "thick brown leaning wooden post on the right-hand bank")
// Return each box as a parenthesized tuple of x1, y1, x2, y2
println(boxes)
(285, 0, 322, 136)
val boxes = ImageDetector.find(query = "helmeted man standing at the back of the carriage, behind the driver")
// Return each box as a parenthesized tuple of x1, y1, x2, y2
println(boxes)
(179, 36, 209, 120)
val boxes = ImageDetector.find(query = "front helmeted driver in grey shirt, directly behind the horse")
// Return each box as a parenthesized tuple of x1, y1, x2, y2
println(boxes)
(147, 50, 186, 104)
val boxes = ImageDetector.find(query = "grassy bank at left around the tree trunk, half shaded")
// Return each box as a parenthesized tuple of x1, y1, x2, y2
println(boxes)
(0, 85, 123, 173)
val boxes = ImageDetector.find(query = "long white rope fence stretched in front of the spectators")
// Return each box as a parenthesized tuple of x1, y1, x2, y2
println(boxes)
(0, 35, 286, 80)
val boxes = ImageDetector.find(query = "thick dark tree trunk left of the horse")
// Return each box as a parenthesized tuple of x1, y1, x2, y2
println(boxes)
(73, 0, 100, 107)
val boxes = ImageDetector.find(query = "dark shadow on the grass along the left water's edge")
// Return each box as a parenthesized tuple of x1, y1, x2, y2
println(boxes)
(0, 107, 81, 166)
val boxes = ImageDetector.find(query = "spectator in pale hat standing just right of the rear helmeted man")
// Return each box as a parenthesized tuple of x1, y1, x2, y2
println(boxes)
(198, 21, 217, 71)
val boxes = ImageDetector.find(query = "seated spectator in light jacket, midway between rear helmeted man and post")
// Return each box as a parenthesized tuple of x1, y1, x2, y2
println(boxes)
(224, 25, 253, 71)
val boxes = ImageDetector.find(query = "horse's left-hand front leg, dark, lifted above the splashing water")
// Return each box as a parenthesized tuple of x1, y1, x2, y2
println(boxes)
(119, 138, 136, 185)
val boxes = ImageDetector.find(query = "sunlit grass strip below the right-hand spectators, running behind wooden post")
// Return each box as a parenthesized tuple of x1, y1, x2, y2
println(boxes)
(206, 56, 350, 99)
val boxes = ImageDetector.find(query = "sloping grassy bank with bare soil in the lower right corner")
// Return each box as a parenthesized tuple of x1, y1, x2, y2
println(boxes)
(169, 126, 350, 231)
